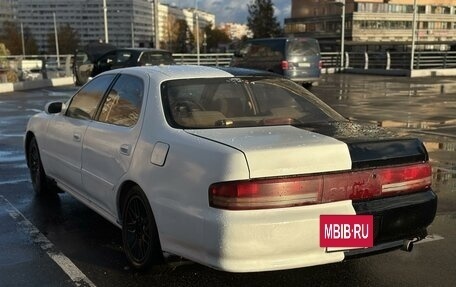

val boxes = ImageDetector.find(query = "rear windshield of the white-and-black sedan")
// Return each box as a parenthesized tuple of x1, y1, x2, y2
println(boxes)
(162, 77, 345, 129)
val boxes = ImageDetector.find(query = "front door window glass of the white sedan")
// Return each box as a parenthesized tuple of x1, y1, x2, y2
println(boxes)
(66, 75, 115, 120)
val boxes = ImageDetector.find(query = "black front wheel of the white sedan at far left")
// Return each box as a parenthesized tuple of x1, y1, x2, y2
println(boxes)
(27, 137, 50, 195)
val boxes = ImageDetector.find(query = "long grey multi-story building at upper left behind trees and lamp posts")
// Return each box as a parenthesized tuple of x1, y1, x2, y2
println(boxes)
(5, 0, 215, 53)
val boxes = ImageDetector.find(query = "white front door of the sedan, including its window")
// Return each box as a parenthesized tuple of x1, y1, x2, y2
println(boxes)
(43, 75, 115, 196)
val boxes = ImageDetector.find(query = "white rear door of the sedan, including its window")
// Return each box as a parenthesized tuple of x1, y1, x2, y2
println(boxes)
(82, 74, 147, 215)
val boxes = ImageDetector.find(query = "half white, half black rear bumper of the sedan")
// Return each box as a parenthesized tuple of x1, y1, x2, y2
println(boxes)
(176, 190, 437, 272)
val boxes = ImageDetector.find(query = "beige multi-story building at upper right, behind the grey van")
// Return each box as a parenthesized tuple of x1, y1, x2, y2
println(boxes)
(285, 0, 456, 50)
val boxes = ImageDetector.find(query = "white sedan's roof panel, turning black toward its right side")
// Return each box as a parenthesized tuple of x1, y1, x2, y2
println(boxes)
(109, 65, 282, 81)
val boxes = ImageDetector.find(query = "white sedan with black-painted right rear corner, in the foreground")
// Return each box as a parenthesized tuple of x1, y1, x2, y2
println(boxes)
(25, 65, 437, 272)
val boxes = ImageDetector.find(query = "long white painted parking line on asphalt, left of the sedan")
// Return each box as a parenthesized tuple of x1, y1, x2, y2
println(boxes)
(0, 195, 95, 287)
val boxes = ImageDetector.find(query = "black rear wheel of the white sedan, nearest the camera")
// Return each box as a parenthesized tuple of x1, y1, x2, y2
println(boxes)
(122, 186, 163, 270)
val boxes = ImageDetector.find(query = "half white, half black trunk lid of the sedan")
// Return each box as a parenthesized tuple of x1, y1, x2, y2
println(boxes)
(187, 122, 428, 178)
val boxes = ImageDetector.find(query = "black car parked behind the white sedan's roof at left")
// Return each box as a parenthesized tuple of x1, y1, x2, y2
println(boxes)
(73, 43, 175, 85)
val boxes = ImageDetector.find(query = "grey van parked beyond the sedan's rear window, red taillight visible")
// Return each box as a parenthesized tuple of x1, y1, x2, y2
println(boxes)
(230, 37, 321, 86)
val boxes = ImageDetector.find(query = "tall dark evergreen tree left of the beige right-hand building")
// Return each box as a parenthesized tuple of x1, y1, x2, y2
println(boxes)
(247, 0, 282, 38)
